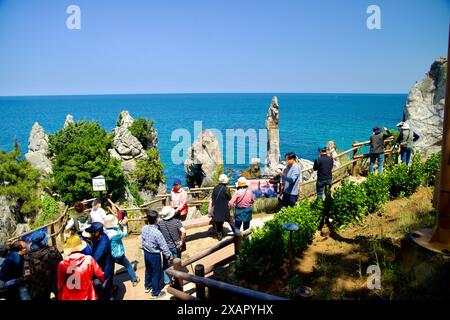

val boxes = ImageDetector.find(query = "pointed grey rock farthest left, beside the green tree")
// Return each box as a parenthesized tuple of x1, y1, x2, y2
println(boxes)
(25, 122, 52, 176)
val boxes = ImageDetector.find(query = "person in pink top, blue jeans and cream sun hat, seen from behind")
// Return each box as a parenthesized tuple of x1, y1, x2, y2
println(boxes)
(228, 177, 255, 231)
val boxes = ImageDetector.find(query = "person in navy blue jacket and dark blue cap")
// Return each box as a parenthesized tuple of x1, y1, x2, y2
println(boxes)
(85, 222, 114, 300)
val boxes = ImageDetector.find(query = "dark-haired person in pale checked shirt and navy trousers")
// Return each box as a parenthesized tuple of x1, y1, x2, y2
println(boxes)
(141, 210, 173, 299)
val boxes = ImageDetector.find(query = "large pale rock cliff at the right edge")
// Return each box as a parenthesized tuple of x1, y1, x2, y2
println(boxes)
(403, 57, 447, 157)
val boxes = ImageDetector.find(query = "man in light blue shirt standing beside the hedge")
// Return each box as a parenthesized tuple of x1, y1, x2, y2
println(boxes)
(279, 152, 302, 207)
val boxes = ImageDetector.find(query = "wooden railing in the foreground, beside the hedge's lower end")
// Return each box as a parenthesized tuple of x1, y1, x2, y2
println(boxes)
(166, 230, 286, 300)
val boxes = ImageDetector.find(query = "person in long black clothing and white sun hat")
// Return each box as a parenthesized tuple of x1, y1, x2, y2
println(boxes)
(211, 173, 235, 241)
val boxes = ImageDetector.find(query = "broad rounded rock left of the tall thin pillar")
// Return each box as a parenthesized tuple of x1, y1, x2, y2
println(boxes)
(184, 129, 223, 187)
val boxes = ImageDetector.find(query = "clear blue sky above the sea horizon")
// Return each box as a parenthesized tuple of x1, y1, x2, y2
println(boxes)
(0, 0, 450, 96)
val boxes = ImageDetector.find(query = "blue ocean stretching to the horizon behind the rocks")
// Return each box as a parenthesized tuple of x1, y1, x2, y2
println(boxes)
(0, 93, 406, 183)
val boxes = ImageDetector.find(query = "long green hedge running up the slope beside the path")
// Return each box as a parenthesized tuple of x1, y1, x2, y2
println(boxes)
(235, 155, 439, 279)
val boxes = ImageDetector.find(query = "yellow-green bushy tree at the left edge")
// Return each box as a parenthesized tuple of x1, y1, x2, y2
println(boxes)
(0, 143, 41, 215)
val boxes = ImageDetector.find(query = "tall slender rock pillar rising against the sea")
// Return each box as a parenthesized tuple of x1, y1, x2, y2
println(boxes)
(264, 97, 281, 176)
